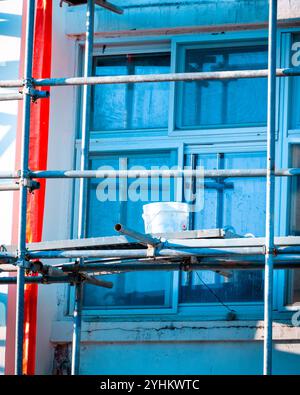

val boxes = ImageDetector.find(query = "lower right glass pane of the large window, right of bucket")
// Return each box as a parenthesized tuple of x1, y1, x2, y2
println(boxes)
(180, 152, 266, 303)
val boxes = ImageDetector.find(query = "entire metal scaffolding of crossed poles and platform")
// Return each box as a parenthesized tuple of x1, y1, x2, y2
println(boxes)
(0, 0, 300, 375)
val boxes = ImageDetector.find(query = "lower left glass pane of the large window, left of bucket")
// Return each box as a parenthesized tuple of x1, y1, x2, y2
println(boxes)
(84, 151, 176, 309)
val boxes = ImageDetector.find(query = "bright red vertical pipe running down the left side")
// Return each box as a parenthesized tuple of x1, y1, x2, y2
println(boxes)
(23, 0, 52, 375)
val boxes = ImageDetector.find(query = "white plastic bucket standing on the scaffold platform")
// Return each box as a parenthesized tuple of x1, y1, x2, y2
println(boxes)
(142, 202, 189, 233)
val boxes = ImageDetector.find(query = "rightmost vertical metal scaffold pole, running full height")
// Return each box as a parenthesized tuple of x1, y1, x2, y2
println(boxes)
(263, 0, 277, 375)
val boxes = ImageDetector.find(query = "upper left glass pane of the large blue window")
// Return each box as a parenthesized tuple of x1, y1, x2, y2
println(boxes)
(92, 53, 170, 131)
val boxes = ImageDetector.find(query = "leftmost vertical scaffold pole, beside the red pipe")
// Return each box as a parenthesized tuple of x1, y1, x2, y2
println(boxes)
(15, 0, 35, 375)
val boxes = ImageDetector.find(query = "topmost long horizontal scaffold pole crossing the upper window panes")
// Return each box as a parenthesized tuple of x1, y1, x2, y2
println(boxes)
(0, 68, 300, 88)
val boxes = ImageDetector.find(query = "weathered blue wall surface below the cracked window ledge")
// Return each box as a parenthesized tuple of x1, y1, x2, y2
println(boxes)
(81, 342, 300, 375)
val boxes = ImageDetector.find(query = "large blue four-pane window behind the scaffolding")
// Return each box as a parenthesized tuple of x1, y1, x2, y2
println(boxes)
(76, 41, 274, 315)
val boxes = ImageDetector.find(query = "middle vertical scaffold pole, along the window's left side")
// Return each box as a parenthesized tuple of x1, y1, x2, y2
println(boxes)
(71, 0, 95, 375)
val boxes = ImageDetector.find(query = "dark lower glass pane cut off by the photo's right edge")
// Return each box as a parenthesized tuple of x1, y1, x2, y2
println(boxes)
(286, 144, 300, 305)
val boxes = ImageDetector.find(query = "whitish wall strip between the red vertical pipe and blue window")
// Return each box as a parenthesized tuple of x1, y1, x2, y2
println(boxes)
(36, 1, 76, 374)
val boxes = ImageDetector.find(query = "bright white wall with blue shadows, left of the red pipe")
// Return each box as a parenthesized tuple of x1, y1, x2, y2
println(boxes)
(0, 0, 23, 374)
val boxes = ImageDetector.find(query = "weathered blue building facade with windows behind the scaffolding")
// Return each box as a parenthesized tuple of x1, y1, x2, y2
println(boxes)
(0, 0, 300, 374)
